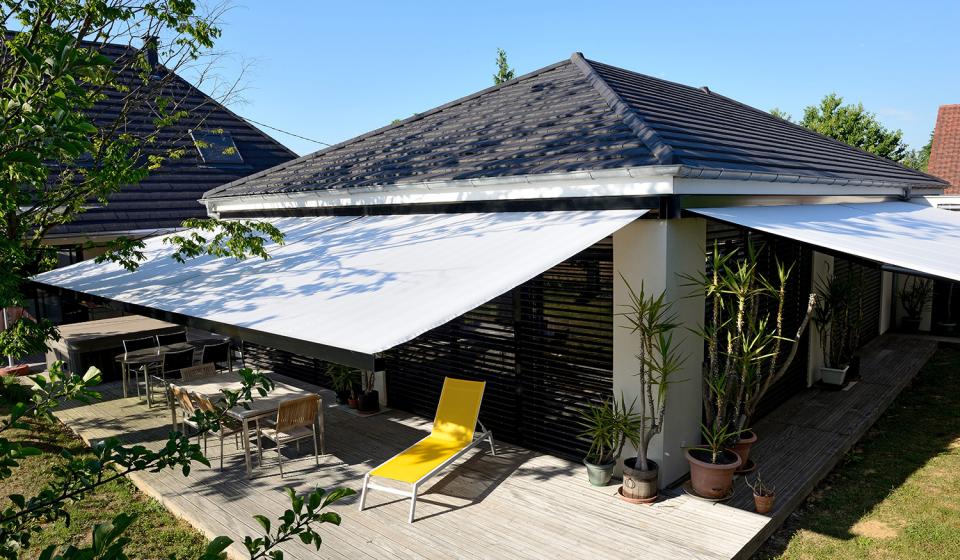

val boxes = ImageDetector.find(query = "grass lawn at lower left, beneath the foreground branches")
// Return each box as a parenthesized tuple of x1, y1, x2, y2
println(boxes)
(0, 384, 206, 559)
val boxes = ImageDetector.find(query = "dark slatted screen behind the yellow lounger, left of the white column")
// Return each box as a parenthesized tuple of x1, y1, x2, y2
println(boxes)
(245, 238, 613, 458)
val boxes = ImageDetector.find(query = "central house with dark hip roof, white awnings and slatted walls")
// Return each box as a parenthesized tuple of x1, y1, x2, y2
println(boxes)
(35, 53, 960, 484)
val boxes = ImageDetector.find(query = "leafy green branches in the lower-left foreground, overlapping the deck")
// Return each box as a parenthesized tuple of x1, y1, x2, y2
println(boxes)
(0, 364, 354, 560)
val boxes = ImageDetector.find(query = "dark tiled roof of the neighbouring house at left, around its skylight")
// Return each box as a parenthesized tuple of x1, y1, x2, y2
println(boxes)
(51, 40, 296, 236)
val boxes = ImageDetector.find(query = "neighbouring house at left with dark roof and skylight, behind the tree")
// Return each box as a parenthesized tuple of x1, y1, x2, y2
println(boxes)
(31, 38, 296, 323)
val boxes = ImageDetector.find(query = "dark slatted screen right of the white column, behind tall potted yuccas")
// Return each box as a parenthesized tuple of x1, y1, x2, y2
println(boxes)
(706, 221, 811, 416)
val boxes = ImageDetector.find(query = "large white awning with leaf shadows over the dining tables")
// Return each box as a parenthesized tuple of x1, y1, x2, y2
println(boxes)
(33, 210, 646, 366)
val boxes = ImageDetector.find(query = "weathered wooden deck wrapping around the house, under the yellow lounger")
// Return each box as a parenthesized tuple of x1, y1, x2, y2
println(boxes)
(50, 337, 935, 560)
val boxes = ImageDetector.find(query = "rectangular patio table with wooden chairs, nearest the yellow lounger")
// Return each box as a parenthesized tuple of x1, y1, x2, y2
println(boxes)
(168, 373, 326, 478)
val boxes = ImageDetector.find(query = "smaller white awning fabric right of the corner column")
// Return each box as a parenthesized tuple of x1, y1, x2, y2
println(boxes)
(691, 202, 960, 281)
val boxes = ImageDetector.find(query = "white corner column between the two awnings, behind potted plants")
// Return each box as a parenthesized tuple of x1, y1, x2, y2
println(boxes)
(613, 218, 706, 485)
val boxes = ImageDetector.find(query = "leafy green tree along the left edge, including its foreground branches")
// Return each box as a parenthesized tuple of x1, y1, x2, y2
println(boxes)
(0, 0, 352, 560)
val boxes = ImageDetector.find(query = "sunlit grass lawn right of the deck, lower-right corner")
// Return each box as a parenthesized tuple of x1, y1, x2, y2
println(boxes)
(757, 346, 960, 560)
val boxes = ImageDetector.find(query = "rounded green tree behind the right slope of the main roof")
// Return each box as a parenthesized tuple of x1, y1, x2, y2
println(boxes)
(770, 93, 908, 163)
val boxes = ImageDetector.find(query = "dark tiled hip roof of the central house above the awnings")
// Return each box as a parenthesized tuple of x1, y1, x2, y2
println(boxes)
(204, 53, 943, 198)
